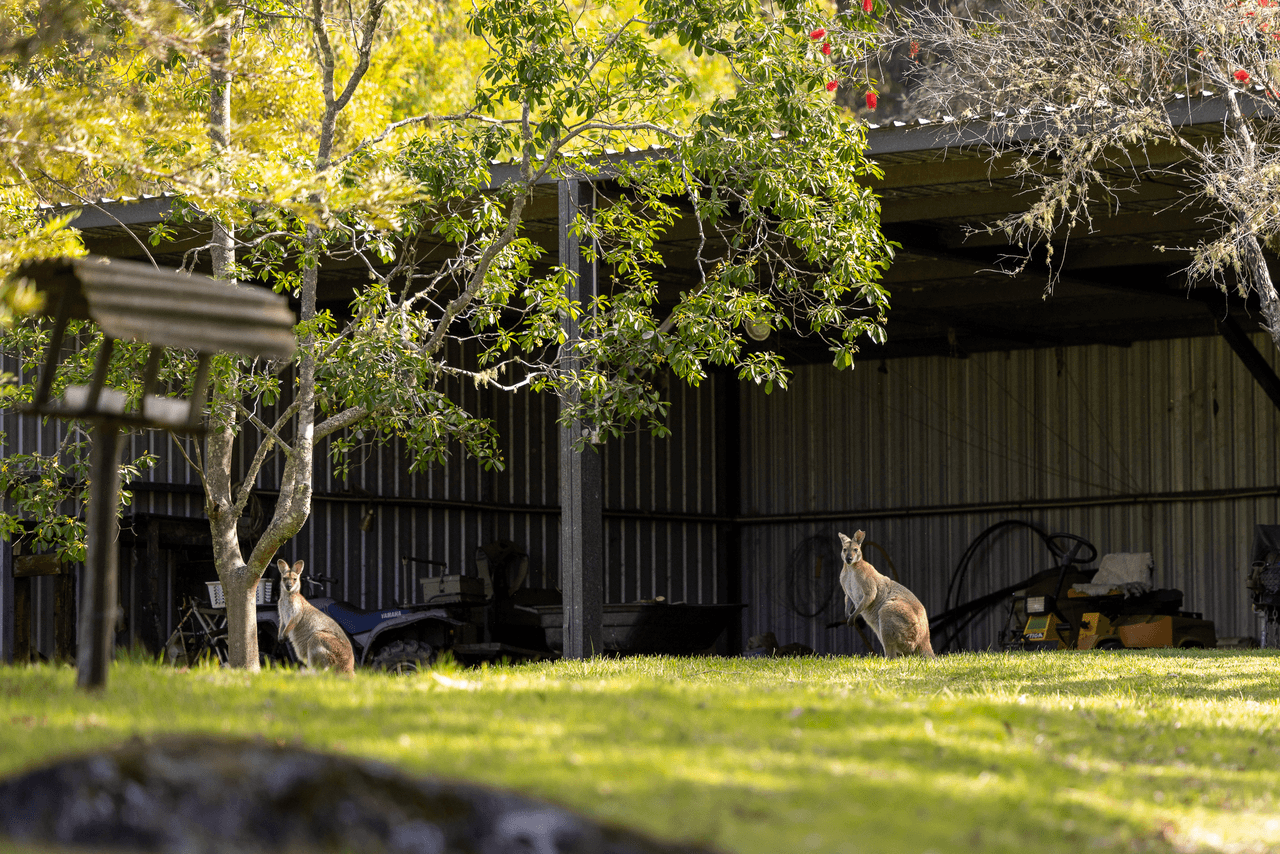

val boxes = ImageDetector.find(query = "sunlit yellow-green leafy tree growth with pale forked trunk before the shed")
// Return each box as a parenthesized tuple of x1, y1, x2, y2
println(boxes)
(0, 0, 891, 666)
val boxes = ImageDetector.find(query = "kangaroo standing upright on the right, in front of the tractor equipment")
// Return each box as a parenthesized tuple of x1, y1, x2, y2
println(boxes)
(840, 531, 934, 658)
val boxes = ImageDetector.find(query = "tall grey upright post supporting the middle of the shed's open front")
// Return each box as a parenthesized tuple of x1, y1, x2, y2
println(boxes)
(559, 179, 604, 658)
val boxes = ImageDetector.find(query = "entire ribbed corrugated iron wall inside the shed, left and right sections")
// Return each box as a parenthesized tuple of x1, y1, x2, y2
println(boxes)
(0, 337, 1280, 653)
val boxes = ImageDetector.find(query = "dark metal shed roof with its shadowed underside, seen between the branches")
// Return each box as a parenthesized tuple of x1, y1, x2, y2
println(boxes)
(37, 93, 1258, 361)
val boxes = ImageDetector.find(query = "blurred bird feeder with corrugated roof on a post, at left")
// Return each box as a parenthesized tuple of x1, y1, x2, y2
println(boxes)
(18, 256, 296, 689)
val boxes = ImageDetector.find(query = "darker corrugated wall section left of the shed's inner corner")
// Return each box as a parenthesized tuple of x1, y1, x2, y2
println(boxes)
(0, 348, 719, 660)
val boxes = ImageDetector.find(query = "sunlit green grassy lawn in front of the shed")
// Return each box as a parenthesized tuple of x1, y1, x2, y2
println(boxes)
(0, 650, 1280, 854)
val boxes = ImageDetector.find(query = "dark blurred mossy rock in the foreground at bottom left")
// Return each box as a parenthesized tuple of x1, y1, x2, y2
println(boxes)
(0, 736, 708, 854)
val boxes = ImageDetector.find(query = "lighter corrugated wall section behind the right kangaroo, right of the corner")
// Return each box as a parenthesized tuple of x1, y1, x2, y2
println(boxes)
(742, 335, 1280, 652)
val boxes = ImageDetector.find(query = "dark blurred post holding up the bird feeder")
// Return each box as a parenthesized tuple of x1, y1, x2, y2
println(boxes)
(76, 419, 120, 689)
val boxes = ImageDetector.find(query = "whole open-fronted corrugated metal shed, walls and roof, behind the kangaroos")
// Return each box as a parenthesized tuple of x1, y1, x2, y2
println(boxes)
(10, 99, 1280, 652)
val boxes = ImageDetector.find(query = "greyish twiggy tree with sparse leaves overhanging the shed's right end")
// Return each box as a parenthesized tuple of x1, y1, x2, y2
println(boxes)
(884, 0, 1280, 346)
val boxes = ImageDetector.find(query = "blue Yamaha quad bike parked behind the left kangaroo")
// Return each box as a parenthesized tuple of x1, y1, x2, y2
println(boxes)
(257, 575, 467, 672)
